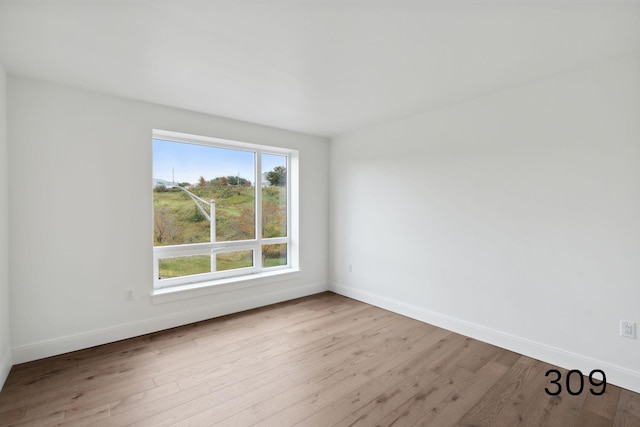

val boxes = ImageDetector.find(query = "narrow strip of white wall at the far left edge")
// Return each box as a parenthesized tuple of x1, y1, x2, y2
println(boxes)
(0, 66, 13, 390)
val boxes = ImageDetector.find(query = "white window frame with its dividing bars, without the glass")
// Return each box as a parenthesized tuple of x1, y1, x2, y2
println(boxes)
(152, 129, 299, 291)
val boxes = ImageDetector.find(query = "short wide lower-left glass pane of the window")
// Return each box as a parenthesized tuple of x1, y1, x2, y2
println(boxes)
(159, 249, 253, 279)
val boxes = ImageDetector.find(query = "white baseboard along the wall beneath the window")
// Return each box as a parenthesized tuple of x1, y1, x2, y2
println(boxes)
(12, 283, 329, 366)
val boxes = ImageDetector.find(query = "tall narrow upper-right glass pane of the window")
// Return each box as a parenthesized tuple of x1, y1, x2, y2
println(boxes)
(260, 154, 287, 238)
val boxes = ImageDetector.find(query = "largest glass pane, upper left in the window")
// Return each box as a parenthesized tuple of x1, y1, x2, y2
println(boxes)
(153, 139, 255, 246)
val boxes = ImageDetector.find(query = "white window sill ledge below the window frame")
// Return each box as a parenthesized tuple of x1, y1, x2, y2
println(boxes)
(151, 269, 300, 304)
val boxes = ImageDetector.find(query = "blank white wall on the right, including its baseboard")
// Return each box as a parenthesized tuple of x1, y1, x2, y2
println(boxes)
(329, 56, 640, 391)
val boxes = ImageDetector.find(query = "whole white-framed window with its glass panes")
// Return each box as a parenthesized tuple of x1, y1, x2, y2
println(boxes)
(152, 130, 297, 289)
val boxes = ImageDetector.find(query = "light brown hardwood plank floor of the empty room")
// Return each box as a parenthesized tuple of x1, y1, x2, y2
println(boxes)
(0, 293, 640, 427)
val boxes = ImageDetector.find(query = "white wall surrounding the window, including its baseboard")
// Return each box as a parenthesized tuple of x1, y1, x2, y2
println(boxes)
(8, 76, 329, 363)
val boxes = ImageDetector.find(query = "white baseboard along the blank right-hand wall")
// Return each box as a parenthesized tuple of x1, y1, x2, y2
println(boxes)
(329, 283, 640, 393)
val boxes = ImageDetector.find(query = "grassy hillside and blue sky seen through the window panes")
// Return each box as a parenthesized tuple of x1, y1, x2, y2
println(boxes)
(153, 139, 287, 280)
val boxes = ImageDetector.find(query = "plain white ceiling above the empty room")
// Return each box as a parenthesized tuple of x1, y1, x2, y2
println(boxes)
(0, 0, 640, 137)
